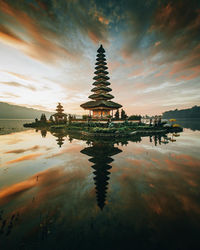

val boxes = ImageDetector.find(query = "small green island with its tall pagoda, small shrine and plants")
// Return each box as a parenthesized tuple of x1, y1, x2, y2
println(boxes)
(24, 45, 183, 138)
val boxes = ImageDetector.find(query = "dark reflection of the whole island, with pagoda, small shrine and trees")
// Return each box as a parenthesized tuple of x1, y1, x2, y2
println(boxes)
(41, 129, 182, 210)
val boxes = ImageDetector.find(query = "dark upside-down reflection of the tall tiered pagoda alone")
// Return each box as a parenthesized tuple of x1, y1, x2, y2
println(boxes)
(81, 142, 122, 209)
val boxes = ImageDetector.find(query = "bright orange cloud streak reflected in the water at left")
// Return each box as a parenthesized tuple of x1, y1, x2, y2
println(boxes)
(0, 166, 88, 206)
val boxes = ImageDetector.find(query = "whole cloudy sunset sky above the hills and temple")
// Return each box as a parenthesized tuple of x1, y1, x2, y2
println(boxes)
(0, 0, 200, 115)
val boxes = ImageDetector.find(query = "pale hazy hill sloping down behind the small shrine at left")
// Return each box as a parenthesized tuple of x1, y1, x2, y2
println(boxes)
(0, 102, 53, 119)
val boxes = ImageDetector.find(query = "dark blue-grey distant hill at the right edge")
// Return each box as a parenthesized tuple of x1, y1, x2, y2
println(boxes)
(163, 106, 200, 119)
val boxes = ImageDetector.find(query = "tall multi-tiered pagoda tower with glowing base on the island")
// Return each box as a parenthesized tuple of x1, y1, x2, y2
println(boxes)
(81, 45, 122, 118)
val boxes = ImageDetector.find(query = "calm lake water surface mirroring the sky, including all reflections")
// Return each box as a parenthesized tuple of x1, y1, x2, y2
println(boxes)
(0, 120, 200, 250)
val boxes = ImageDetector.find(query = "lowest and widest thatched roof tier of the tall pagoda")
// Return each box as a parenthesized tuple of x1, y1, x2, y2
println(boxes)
(81, 100, 122, 110)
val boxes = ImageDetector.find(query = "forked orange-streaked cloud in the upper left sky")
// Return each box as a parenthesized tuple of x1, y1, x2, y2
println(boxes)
(0, 2, 71, 62)
